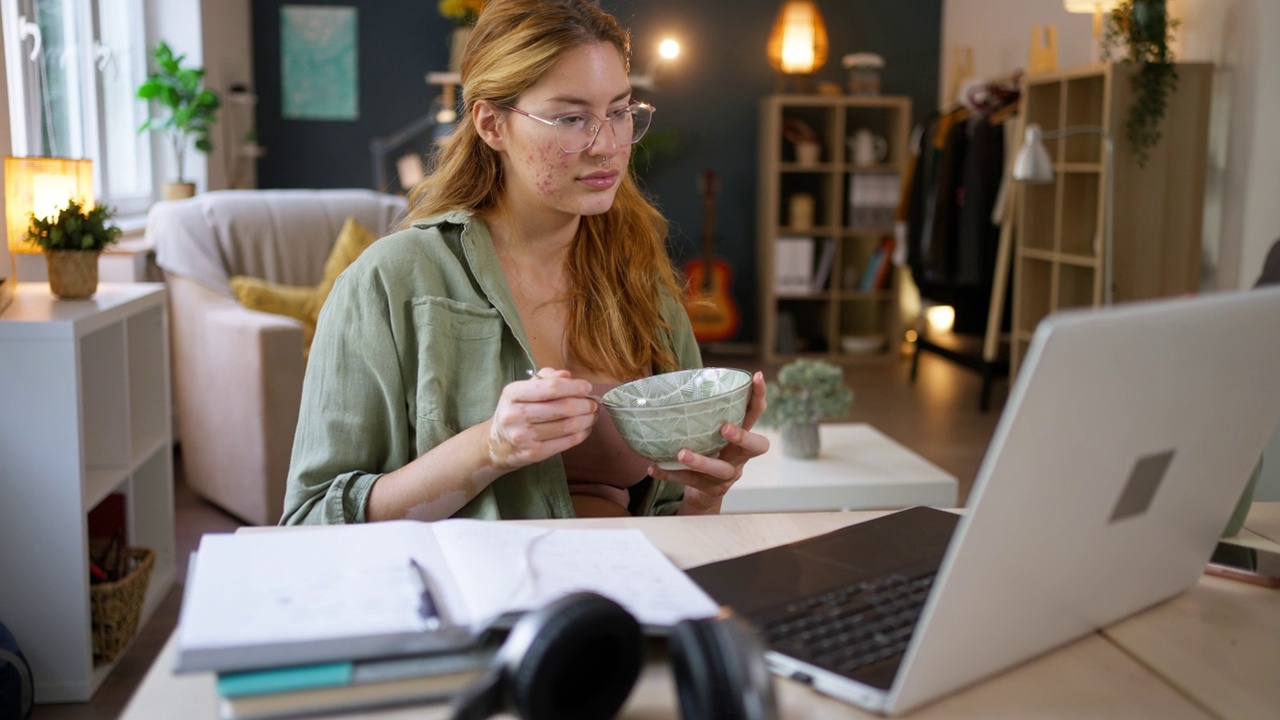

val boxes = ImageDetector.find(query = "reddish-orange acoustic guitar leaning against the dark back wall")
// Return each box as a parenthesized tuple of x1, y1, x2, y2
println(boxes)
(685, 170, 741, 342)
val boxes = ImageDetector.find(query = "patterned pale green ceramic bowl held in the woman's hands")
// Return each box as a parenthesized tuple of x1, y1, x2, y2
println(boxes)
(602, 368, 751, 470)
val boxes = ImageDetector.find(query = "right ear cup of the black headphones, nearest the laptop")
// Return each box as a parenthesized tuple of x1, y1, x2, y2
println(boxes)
(667, 615, 778, 720)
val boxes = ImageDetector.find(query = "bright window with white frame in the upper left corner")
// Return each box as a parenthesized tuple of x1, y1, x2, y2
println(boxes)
(0, 0, 154, 214)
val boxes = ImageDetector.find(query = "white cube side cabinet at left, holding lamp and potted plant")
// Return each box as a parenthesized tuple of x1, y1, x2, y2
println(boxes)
(0, 283, 175, 702)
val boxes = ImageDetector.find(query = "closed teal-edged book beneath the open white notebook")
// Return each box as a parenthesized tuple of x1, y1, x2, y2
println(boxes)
(215, 646, 495, 720)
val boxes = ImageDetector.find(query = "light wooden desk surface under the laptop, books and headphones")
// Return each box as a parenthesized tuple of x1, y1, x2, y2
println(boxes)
(122, 503, 1280, 720)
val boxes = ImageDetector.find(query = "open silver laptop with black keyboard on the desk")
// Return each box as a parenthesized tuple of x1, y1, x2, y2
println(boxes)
(690, 288, 1280, 715)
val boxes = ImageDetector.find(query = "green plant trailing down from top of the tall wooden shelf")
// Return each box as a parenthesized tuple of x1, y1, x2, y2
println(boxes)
(1103, 0, 1178, 167)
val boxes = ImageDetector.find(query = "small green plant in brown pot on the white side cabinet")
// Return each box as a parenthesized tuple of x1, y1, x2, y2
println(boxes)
(27, 200, 120, 300)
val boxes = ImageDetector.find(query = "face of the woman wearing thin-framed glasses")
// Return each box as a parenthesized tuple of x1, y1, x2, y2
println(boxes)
(495, 42, 631, 215)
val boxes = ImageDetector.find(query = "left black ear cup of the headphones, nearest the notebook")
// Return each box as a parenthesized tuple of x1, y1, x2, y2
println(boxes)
(508, 593, 644, 720)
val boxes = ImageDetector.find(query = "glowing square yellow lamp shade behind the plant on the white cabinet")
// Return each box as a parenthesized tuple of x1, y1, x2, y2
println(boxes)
(4, 156, 93, 252)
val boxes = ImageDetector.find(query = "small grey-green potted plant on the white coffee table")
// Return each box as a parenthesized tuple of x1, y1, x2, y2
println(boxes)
(760, 360, 854, 459)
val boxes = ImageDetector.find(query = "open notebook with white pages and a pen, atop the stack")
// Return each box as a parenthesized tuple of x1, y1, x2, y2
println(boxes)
(177, 519, 718, 673)
